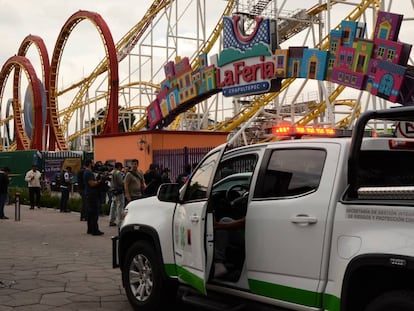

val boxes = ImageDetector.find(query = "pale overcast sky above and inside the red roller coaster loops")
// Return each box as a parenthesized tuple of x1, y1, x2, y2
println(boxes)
(0, 0, 414, 83)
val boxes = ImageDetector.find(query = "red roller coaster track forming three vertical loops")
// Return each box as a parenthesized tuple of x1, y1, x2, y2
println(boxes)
(0, 11, 119, 150)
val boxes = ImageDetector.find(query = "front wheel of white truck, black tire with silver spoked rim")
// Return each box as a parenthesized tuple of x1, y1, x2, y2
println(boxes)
(122, 241, 176, 311)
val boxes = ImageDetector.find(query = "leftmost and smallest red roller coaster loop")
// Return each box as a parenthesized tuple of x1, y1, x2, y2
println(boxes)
(0, 56, 42, 151)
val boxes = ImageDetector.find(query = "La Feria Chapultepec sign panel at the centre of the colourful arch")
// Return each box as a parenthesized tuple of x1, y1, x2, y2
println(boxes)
(212, 15, 281, 96)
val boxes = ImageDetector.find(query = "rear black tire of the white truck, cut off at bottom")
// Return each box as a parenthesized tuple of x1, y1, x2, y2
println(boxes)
(365, 290, 414, 311)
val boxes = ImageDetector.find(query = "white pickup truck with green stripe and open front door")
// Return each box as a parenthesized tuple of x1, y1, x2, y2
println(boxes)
(112, 107, 414, 311)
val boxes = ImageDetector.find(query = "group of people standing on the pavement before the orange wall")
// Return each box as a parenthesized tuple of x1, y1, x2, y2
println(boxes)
(0, 159, 186, 235)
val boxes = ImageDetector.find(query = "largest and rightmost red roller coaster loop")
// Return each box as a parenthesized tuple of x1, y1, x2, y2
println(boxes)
(49, 10, 119, 150)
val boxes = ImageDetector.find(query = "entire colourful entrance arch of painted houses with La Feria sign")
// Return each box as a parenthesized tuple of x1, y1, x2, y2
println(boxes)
(147, 12, 414, 129)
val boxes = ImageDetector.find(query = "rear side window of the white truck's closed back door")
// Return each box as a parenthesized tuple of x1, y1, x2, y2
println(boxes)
(255, 149, 326, 198)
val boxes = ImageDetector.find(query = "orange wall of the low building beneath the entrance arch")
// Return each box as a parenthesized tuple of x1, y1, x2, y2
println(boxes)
(94, 131, 228, 171)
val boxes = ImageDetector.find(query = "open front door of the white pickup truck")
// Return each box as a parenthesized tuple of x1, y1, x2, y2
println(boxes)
(173, 144, 226, 294)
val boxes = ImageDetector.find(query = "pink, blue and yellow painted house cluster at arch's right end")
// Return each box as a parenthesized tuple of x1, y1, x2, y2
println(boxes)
(328, 12, 411, 103)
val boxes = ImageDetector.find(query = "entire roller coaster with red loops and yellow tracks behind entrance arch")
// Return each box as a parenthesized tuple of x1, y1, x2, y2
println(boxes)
(0, 0, 414, 151)
